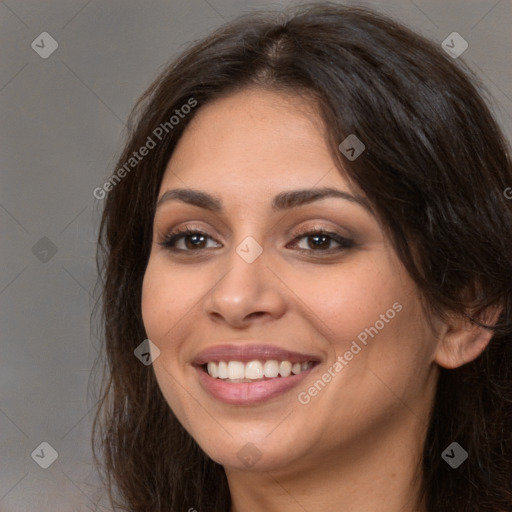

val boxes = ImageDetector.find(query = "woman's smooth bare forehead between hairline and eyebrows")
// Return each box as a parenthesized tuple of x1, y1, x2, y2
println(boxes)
(158, 88, 354, 197)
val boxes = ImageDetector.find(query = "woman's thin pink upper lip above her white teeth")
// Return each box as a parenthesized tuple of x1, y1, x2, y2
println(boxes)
(192, 344, 319, 366)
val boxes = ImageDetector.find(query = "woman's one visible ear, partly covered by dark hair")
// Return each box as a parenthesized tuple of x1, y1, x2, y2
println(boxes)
(434, 307, 503, 369)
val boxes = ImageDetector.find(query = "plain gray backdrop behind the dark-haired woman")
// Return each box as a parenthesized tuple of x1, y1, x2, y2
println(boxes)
(0, 0, 512, 512)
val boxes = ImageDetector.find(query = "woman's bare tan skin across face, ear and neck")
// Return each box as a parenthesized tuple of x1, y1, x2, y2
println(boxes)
(142, 88, 490, 512)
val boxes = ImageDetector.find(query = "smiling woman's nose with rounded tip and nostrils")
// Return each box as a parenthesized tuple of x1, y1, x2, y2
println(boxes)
(204, 243, 286, 329)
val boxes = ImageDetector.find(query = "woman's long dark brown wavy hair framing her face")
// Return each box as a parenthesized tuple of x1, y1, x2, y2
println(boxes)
(92, 3, 512, 512)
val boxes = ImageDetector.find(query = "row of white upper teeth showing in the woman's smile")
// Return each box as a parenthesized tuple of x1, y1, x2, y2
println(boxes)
(206, 359, 313, 382)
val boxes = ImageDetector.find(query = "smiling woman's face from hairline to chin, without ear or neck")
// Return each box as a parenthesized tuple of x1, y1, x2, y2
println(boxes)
(142, 89, 437, 471)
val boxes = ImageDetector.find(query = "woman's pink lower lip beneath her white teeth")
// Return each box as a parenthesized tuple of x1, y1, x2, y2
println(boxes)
(196, 367, 314, 405)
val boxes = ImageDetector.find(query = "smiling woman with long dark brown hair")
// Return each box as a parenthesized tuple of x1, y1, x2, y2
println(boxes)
(94, 4, 512, 512)
